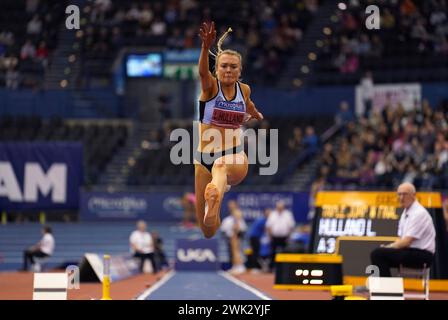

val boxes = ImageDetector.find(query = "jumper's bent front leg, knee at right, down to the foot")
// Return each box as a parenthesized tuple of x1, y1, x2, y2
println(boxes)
(204, 152, 248, 232)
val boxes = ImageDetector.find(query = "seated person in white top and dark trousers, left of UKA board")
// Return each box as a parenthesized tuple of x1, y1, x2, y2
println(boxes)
(129, 220, 157, 273)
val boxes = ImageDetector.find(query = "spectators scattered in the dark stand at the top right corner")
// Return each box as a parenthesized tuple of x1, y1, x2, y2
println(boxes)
(321, 0, 448, 73)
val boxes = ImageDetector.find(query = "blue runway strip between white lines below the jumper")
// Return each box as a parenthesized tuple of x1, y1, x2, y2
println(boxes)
(146, 271, 270, 300)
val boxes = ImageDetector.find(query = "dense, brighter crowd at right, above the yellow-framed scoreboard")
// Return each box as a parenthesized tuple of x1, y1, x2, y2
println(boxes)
(318, 98, 448, 189)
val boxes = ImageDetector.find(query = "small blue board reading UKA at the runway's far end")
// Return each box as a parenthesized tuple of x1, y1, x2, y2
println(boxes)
(175, 239, 219, 271)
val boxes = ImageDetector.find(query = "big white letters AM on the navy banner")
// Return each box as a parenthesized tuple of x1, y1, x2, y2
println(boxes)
(0, 161, 67, 203)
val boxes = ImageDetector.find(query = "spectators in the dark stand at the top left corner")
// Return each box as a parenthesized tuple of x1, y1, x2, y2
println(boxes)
(0, 0, 65, 90)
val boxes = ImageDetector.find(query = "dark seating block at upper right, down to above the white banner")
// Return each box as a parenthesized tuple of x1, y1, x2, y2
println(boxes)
(311, 0, 448, 85)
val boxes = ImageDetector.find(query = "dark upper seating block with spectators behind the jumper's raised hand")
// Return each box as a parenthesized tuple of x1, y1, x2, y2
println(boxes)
(81, 0, 318, 83)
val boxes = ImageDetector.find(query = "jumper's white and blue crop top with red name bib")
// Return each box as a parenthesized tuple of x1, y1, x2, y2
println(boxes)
(199, 80, 246, 129)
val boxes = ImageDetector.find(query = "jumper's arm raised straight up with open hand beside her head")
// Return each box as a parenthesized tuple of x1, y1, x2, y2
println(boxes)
(198, 22, 216, 92)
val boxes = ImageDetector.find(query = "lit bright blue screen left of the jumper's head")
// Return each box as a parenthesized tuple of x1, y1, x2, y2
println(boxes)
(126, 52, 163, 78)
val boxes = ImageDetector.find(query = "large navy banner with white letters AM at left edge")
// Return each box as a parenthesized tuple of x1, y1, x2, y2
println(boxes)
(0, 142, 83, 210)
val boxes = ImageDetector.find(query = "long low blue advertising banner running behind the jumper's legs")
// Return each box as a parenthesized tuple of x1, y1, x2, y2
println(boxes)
(80, 191, 309, 223)
